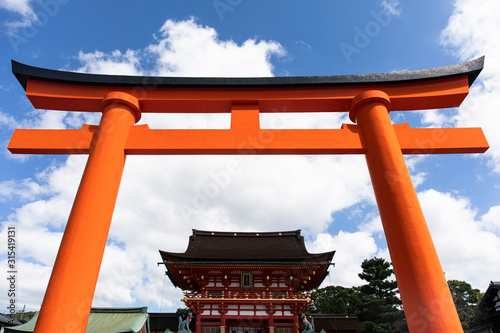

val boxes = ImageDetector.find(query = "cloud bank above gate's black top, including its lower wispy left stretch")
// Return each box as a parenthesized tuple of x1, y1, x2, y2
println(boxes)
(77, 18, 285, 77)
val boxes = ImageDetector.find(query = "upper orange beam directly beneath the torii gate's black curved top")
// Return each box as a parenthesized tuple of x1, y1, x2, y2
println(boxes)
(26, 75, 469, 113)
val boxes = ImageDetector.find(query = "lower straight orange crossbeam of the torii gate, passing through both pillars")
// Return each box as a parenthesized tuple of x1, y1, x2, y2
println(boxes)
(8, 124, 489, 155)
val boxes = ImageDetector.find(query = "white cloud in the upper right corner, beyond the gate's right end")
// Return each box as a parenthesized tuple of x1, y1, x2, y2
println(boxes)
(440, 0, 500, 172)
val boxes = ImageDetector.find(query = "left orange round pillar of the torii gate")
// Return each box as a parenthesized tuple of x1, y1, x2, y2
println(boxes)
(35, 92, 141, 333)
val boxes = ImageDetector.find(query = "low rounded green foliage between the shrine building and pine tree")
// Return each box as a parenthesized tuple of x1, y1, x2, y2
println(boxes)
(309, 286, 360, 313)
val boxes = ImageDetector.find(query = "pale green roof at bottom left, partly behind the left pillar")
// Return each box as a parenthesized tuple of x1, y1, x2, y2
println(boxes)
(6, 307, 149, 333)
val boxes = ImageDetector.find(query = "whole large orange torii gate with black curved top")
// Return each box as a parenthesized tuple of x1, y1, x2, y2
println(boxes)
(8, 57, 488, 333)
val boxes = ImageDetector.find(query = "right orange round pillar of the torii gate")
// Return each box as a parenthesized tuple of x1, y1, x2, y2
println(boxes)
(349, 90, 463, 332)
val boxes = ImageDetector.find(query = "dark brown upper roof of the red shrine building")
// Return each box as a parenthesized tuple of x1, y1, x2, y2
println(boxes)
(160, 230, 335, 263)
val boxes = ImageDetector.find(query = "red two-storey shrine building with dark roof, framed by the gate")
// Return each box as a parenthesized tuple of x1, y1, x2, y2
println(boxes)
(160, 230, 335, 333)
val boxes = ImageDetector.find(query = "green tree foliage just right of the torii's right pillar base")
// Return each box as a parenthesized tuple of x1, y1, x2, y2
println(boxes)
(448, 280, 485, 330)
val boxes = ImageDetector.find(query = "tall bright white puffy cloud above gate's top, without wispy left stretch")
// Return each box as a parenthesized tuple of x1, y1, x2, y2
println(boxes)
(148, 18, 285, 77)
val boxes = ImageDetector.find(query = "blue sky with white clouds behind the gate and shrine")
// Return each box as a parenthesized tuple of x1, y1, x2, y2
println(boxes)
(0, 0, 500, 311)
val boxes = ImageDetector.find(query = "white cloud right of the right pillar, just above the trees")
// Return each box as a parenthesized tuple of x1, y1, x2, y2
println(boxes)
(419, 190, 500, 290)
